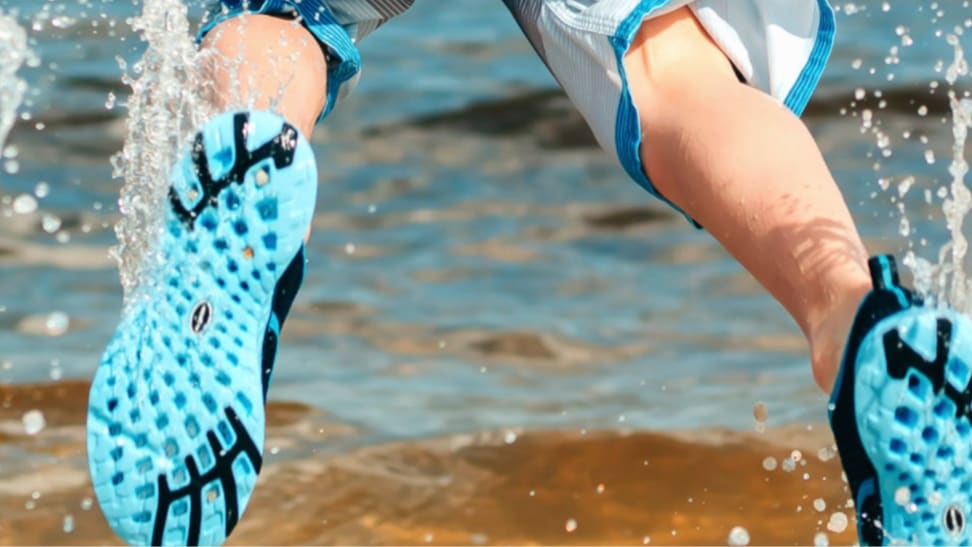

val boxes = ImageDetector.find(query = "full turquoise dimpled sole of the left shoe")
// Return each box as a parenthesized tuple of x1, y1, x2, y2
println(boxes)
(87, 112, 317, 545)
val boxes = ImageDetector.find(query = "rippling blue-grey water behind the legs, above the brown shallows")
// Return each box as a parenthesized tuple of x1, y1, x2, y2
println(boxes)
(0, 0, 972, 543)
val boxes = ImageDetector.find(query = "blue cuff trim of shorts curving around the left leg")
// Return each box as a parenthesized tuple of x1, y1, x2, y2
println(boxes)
(196, 0, 361, 121)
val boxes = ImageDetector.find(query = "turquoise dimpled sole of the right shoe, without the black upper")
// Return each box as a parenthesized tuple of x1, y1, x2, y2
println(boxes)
(854, 307, 972, 545)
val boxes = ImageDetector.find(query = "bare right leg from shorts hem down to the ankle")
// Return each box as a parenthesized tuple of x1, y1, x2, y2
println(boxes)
(624, 8, 870, 392)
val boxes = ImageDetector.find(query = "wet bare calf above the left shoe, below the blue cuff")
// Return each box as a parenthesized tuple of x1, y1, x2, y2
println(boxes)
(202, 15, 327, 137)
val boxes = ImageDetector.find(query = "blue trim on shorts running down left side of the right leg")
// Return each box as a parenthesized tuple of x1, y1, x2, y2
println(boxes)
(608, 0, 702, 228)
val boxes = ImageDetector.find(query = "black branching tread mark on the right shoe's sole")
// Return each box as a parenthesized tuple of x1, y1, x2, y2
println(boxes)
(884, 319, 972, 419)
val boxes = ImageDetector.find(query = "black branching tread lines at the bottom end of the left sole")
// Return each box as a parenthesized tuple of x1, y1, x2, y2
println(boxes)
(152, 406, 263, 545)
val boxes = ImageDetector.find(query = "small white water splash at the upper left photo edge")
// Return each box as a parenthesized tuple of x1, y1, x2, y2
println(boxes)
(0, 10, 38, 154)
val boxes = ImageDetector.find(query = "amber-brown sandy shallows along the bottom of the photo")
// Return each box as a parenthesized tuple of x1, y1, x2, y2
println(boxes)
(0, 382, 856, 545)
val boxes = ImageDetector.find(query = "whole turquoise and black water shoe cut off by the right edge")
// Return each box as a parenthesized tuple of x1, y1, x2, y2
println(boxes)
(830, 256, 972, 545)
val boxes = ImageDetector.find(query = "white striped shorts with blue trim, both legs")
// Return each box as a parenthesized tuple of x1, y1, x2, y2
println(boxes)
(202, 0, 834, 220)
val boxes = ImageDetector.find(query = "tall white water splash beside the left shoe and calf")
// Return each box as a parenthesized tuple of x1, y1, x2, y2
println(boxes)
(112, 0, 215, 305)
